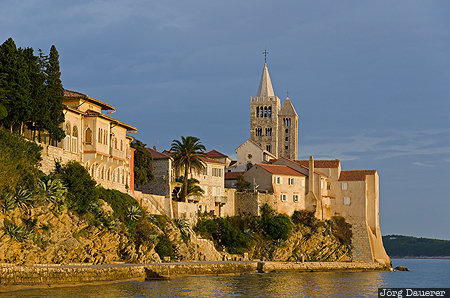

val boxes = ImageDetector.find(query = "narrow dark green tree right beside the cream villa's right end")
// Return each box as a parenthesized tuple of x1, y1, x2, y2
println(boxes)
(131, 139, 153, 185)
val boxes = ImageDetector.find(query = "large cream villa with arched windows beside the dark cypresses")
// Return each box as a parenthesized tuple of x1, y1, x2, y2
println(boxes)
(35, 90, 137, 192)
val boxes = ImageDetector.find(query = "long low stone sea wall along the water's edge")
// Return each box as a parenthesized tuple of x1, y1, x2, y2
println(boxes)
(0, 261, 391, 292)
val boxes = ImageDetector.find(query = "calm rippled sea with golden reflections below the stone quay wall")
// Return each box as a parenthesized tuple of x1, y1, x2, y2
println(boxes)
(5, 259, 450, 297)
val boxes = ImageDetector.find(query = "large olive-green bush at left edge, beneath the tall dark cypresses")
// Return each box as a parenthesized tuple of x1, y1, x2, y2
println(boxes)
(0, 128, 42, 193)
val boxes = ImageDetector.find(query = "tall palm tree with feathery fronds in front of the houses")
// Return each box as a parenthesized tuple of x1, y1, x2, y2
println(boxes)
(170, 136, 206, 200)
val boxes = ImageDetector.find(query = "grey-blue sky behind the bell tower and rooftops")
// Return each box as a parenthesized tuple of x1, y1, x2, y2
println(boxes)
(0, 0, 450, 239)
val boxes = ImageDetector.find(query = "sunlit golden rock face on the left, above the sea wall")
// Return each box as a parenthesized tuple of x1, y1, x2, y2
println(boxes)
(0, 205, 222, 265)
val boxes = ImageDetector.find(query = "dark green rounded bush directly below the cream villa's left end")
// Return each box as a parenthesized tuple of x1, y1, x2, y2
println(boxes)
(56, 161, 98, 214)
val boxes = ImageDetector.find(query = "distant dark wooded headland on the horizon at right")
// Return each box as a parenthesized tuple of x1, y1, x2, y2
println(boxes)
(383, 235, 450, 257)
